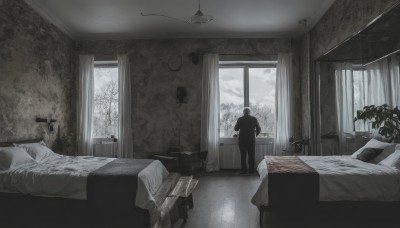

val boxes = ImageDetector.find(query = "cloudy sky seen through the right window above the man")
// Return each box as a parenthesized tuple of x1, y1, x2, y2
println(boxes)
(219, 68, 276, 110)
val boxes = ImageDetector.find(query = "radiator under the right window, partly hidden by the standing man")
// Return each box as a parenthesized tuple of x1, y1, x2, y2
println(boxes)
(219, 139, 274, 169)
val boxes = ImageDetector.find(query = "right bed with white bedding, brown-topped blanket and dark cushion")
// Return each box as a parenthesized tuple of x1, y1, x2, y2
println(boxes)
(251, 140, 400, 224)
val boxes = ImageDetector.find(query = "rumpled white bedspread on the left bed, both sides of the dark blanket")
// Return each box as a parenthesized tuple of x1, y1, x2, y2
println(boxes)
(0, 154, 169, 209)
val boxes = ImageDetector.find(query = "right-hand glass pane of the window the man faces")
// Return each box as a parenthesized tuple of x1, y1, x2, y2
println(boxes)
(249, 68, 276, 137)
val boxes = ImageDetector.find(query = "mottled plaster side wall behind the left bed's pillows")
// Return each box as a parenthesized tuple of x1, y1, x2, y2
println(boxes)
(0, 0, 75, 150)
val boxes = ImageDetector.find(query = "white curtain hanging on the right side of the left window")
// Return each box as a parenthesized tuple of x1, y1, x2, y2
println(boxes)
(117, 55, 133, 158)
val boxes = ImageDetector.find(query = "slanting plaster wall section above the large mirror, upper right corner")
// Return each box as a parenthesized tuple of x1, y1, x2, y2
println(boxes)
(311, 0, 400, 60)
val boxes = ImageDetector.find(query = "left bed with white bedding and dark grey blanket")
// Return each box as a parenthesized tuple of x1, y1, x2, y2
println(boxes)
(0, 140, 179, 227)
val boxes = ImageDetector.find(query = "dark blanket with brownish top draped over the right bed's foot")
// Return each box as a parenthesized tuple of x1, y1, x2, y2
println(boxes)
(266, 156, 319, 207)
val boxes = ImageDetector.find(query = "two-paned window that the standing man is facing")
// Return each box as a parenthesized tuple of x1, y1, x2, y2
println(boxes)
(219, 62, 276, 138)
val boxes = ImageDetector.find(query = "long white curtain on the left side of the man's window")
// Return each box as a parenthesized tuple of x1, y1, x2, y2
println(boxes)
(200, 54, 219, 171)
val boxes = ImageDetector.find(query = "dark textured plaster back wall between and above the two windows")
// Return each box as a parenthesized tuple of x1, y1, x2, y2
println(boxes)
(76, 39, 300, 156)
